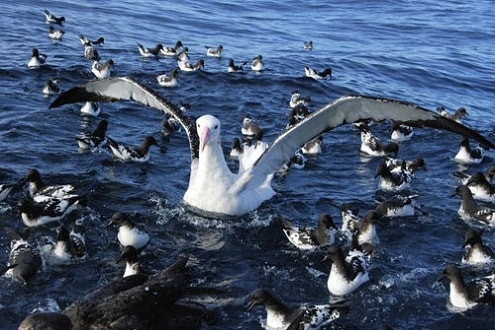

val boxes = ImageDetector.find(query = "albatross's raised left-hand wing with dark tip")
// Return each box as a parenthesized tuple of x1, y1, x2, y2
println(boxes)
(50, 77, 199, 159)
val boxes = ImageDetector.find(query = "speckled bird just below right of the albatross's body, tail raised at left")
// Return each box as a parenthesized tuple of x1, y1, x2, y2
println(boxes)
(278, 214, 337, 250)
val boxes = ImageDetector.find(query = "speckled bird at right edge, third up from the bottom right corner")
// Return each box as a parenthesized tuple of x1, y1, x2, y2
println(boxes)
(452, 185, 495, 227)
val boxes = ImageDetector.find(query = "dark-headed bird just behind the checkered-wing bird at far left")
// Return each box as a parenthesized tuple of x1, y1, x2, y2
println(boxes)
(21, 169, 77, 202)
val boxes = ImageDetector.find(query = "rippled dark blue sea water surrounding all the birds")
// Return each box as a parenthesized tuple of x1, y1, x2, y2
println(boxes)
(0, 0, 495, 329)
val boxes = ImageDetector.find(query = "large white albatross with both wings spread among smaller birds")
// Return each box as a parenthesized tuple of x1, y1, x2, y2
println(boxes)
(50, 77, 495, 216)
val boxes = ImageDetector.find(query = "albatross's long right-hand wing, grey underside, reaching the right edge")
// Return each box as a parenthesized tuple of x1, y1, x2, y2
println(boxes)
(233, 95, 495, 192)
